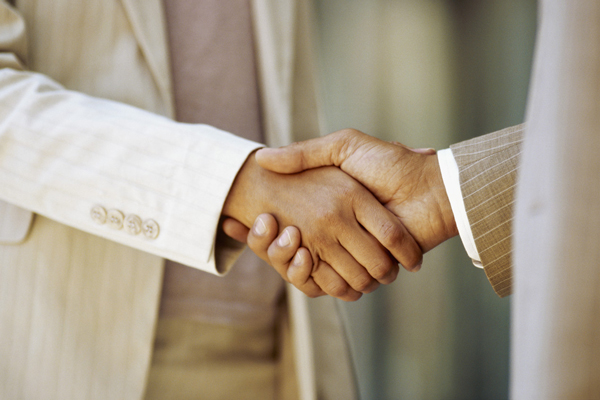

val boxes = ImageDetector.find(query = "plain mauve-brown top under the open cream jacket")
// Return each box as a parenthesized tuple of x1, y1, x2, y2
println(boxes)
(160, 0, 283, 326)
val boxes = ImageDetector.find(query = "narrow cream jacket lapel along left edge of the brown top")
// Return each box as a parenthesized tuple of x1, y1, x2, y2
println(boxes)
(121, 0, 175, 117)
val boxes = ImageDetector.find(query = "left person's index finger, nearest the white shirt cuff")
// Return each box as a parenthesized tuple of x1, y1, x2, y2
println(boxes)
(354, 193, 423, 272)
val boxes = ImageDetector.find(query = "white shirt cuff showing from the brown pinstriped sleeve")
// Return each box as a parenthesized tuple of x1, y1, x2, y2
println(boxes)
(437, 149, 483, 268)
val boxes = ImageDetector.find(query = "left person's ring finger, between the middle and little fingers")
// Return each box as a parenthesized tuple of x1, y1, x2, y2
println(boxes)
(317, 241, 378, 297)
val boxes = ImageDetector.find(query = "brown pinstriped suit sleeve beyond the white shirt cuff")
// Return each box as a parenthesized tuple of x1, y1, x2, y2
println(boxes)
(450, 125, 524, 297)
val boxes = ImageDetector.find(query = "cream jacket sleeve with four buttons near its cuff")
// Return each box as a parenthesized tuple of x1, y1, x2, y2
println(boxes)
(0, 2, 260, 273)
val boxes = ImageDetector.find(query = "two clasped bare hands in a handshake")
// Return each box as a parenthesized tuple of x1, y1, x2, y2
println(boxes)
(223, 129, 458, 301)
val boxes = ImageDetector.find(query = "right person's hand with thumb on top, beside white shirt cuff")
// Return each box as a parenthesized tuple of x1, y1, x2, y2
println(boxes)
(256, 129, 458, 253)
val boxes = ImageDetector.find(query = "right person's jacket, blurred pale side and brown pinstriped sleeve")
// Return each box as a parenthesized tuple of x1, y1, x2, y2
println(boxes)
(453, 0, 600, 400)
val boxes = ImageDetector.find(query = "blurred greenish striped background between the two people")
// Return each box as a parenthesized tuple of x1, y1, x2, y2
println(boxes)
(313, 0, 537, 400)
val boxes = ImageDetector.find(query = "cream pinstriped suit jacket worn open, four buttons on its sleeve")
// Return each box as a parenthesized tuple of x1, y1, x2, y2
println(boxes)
(0, 0, 355, 400)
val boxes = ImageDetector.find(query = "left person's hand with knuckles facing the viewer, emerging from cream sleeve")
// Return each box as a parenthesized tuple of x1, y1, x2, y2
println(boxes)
(223, 152, 422, 300)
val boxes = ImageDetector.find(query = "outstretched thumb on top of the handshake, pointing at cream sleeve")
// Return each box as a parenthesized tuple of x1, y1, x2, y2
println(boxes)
(255, 129, 369, 174)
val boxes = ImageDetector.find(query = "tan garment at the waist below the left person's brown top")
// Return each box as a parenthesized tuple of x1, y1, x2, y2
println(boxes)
(144, 303, 298, 400)
